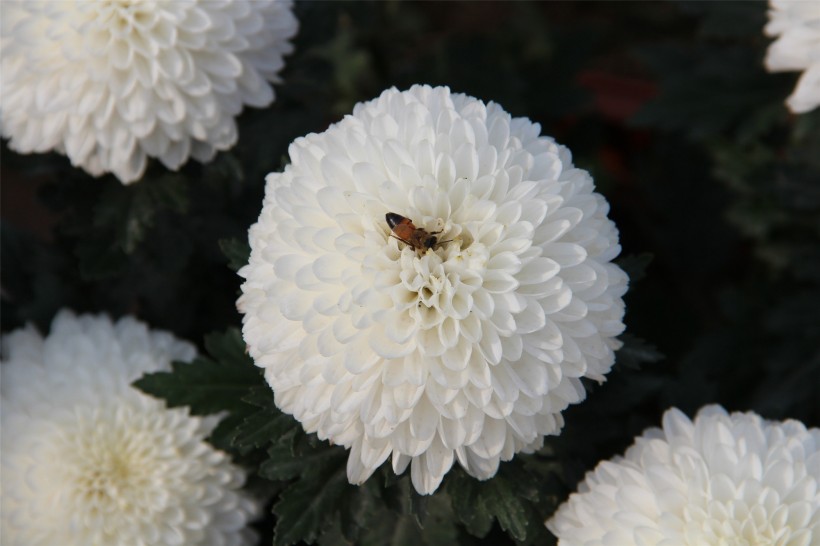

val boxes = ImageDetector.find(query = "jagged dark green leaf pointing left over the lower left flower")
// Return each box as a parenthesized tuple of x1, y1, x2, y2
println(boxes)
(134, 329, 264, 414)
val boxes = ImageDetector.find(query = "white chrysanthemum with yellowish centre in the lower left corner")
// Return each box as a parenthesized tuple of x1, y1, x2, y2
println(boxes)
(0, 312, 259, 546)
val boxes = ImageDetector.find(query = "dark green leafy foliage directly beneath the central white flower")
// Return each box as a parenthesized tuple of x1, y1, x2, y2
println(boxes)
(134, 329, 564, 546)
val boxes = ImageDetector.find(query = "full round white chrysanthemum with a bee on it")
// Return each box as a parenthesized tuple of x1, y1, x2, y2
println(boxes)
(239, 86, 627, 493)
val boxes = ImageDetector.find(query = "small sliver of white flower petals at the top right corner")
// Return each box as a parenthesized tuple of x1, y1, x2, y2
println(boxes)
(766, 0, 820, 114)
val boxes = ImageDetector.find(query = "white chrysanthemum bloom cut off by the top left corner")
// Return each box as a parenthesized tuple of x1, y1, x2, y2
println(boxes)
(0, 0, 298, 183)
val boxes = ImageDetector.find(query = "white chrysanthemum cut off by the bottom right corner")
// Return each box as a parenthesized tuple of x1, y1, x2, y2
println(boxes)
(547, 406, 820, 546)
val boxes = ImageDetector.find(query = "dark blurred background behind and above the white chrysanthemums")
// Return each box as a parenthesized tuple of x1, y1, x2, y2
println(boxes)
(0, 1, 820, 544)
